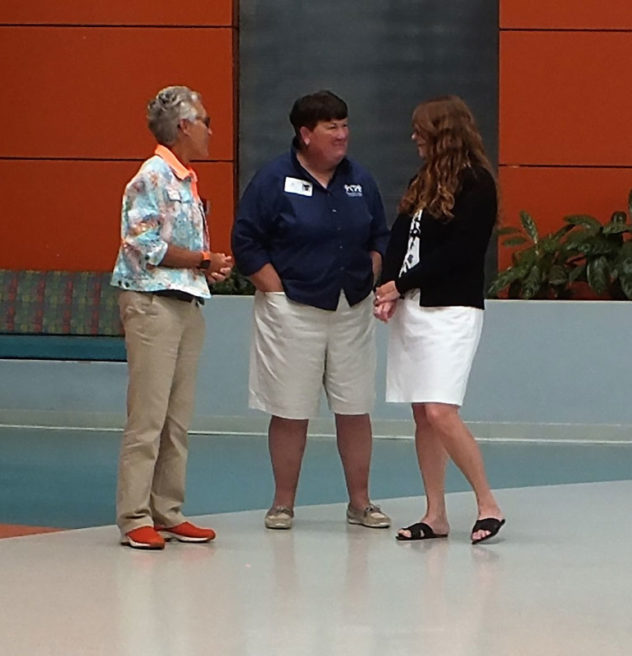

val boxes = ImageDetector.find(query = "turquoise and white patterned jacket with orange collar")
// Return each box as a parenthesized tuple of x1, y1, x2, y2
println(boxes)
(111, 146, 210, 298)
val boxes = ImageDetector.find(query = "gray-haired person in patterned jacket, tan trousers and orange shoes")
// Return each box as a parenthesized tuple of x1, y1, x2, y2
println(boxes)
(112, 86, 232, 549)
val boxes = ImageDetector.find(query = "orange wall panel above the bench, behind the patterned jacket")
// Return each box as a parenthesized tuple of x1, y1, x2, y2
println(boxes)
(0, 161, 233, 271)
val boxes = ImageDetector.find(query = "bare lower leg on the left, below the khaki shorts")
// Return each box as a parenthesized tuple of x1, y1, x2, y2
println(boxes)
(268, 415, 308, 508)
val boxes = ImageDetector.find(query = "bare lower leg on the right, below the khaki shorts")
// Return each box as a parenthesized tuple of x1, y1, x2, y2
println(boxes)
(336, 414, 372, 510)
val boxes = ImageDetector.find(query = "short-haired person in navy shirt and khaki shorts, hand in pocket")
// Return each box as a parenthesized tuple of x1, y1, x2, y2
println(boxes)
(232, 91, 390, 529)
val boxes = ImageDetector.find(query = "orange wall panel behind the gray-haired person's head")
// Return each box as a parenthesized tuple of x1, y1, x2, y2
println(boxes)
(0, 27, 234, 160)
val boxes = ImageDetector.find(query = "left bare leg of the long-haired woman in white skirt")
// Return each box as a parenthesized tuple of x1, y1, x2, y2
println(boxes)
(399, 403, 450, 537)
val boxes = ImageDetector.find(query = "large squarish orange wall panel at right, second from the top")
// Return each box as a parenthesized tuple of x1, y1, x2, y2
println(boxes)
(499, 32, 632, 166)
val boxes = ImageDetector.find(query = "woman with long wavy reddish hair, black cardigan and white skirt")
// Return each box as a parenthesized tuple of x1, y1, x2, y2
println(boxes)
(375, 96, 505, 544)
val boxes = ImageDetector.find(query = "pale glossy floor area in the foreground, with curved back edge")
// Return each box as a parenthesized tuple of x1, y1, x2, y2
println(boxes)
(0, 481, 632, 656)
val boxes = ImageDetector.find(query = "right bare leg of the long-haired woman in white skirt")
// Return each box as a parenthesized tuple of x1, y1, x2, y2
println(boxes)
(424, 403, 503, 539)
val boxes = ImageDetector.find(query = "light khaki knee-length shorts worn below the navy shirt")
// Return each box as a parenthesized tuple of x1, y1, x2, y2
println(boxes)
(249, 292, 376, 419)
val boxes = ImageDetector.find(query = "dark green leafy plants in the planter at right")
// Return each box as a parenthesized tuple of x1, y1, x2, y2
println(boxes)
(488, 191, 632, 300)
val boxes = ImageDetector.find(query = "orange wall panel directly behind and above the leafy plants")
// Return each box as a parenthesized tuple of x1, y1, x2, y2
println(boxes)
(498, 166, 632, 269)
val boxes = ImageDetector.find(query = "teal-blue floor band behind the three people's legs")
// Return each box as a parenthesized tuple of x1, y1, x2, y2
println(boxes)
(0, 428, 632, 528)
